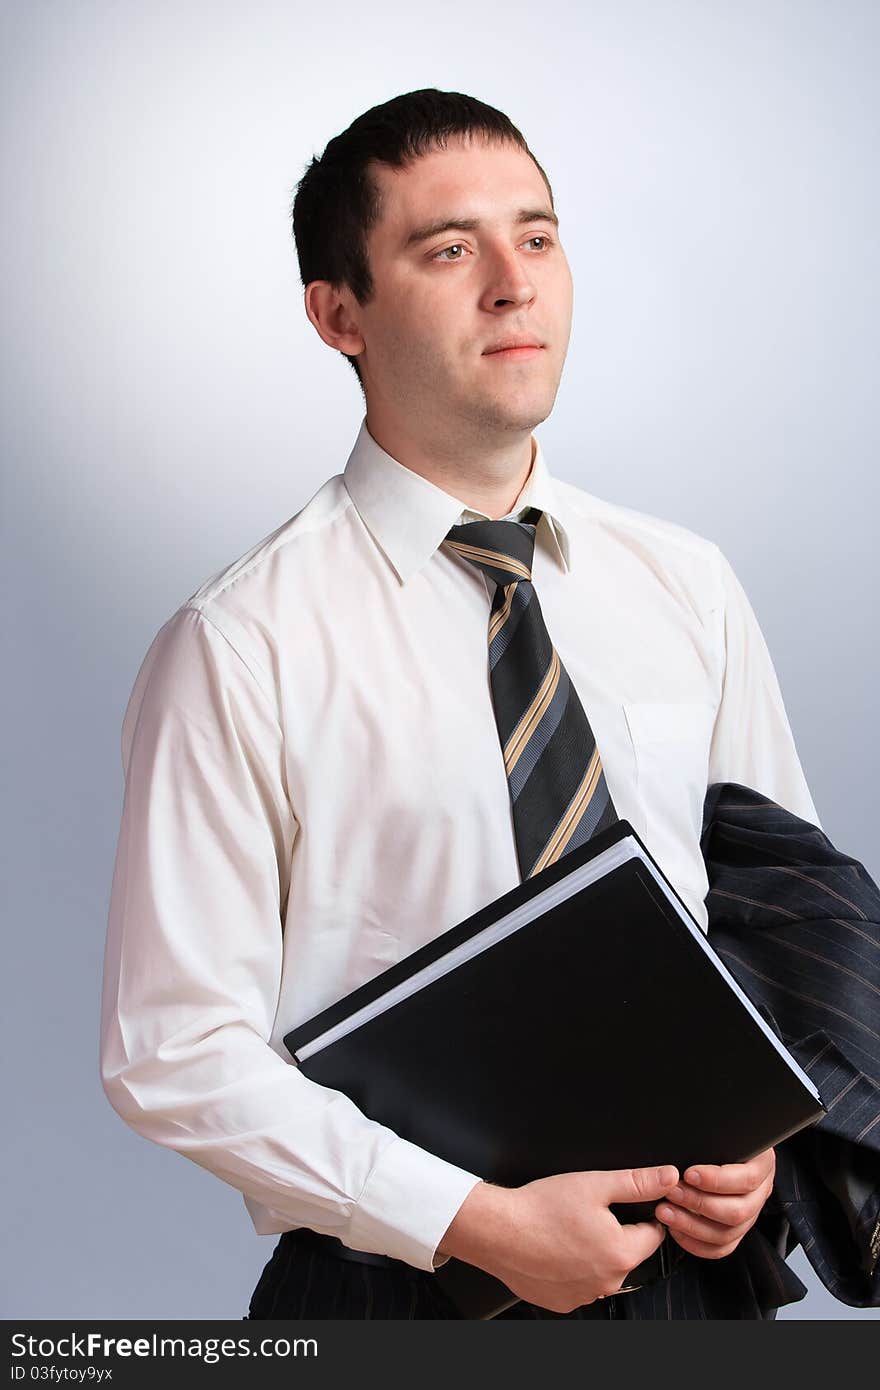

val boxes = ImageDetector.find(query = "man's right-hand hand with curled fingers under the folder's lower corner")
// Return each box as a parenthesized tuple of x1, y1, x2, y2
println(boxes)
(655, 1148, 776, 1259)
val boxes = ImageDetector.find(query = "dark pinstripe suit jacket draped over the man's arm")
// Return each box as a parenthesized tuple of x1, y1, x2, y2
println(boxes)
(617, 783, 880, 1319)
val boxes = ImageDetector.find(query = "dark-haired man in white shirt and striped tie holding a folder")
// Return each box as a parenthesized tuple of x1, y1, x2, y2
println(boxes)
(101, 89, 817, 1318)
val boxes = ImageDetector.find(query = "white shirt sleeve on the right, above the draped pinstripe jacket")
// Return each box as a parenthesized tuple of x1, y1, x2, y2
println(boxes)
(709, 550, 822, 828)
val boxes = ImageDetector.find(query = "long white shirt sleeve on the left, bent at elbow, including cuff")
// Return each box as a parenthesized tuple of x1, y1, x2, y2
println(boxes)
(100, 607, 481, 1270)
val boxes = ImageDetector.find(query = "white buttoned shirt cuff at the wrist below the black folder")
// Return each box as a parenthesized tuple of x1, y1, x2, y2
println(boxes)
(345, 1136, 482, 1273)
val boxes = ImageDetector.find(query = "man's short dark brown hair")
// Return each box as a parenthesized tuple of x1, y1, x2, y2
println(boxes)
(291, 88, 553, 389)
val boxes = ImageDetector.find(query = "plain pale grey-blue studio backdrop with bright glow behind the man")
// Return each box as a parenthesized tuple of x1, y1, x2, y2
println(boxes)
(0, 0, 880, 1319)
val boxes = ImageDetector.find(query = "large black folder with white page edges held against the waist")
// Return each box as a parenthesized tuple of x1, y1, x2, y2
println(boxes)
(284, 820, 824, 1318)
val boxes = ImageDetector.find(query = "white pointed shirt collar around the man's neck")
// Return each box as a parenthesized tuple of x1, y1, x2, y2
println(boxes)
(342, 416, 571, 584)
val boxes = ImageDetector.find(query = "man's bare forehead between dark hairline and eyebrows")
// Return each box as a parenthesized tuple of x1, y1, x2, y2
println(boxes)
(370, 136, 551, 246)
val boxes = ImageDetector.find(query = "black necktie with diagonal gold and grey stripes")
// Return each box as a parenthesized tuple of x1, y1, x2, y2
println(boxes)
(446, 507, 619, 878)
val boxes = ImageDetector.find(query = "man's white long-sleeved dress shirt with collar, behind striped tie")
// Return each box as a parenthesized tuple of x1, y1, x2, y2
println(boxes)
(100, 418, 819, 1270)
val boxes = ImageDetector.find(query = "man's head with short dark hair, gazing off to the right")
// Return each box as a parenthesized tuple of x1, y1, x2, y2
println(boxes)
(293, 89, 571, 458)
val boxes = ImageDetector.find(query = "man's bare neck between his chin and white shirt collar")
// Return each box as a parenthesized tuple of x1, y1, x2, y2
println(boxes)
(367, 411, 535, 518)
